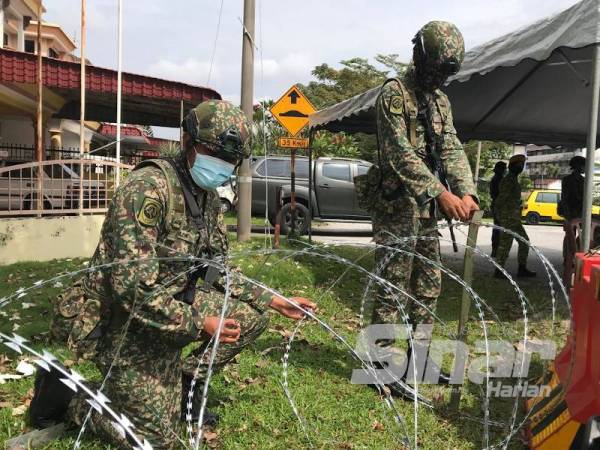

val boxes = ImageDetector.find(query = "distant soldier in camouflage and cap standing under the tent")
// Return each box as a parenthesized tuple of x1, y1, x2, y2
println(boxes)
(494, 155, 536, 278)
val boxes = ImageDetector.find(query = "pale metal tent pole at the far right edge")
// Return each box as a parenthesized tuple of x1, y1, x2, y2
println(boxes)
(582, 44, 600, 252)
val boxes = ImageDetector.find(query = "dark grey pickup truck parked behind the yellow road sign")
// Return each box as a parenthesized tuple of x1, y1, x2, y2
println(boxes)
(251, 156, 371, 233)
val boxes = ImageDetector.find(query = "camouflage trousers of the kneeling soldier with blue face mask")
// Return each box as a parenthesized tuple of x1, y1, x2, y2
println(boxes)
(68, 301, 268, 449)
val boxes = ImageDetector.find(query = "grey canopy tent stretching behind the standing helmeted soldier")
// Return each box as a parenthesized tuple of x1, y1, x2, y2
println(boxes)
(309, 0, 600, 250)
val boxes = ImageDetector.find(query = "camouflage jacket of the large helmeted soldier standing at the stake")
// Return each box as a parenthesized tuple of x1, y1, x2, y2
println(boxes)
(370, 68, 476, 218)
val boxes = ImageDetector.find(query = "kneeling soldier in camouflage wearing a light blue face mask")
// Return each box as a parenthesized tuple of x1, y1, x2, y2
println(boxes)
(30, 100, 315, 448)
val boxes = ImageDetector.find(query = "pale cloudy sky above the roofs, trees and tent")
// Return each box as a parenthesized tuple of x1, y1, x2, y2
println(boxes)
(44, 0, 577, 138)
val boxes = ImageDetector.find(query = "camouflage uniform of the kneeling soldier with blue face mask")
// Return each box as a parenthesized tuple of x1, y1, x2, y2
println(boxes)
(54, 100, 271, 449)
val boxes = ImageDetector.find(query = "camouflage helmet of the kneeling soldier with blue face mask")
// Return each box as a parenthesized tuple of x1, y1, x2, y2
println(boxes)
(182, 100, 252, 163)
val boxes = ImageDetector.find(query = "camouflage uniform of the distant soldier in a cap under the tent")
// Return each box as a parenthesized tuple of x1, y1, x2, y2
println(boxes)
(495, 171, 529, 266)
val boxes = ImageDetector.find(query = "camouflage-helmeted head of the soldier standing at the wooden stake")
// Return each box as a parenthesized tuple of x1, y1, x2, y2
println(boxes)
(413, 21, 465, 89)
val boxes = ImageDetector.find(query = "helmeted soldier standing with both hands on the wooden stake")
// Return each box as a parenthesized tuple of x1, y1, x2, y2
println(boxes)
(357, 21, 478, 397)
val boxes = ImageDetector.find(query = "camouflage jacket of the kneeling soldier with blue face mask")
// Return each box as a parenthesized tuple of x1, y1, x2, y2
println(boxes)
(85, 161, 270, 343)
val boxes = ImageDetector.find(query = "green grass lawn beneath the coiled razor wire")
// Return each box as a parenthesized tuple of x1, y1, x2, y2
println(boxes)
(0, 239, 567, 450)
